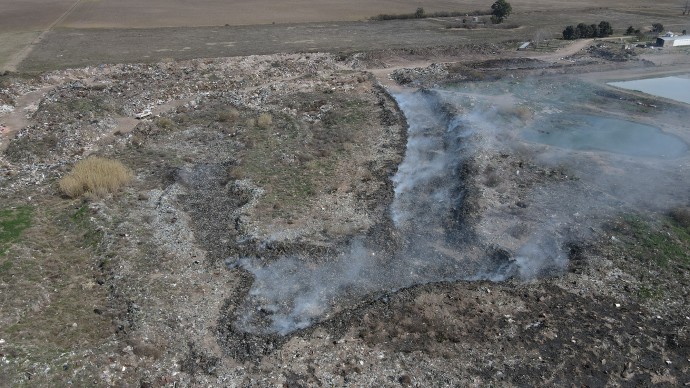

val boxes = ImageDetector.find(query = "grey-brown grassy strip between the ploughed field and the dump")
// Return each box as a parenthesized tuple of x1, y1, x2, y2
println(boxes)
(13, 8, 690, 72)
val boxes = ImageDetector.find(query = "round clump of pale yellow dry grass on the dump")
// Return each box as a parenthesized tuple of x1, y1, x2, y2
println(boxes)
(59, 156, 133, 198)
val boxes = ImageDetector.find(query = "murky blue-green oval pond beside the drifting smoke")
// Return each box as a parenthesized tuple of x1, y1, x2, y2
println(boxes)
(522, 114, 688, 158)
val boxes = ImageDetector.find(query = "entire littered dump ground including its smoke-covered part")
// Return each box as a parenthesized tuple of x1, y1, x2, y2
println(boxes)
(0, 41, 690, 387)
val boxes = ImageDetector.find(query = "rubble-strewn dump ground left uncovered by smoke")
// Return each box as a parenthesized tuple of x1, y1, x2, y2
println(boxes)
(0, 42, 690, 387)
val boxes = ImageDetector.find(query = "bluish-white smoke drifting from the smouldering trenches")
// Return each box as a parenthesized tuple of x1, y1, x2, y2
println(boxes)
(230, 79, 690, 335)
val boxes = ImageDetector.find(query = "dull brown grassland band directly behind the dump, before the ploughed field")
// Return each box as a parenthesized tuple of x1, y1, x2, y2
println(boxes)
(7, 2, 690, 72)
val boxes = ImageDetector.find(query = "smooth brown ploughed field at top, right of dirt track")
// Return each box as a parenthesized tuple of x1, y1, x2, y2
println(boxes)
(47, 0, 681, 28)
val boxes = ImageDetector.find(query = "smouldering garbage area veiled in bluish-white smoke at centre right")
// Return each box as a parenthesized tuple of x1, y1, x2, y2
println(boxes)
(226, 77, 683, 335)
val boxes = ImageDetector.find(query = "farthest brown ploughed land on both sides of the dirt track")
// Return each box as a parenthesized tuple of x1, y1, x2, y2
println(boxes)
(10, 0, 680, 30)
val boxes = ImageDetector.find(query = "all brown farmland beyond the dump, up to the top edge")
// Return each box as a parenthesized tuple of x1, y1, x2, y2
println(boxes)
(0, 0, 682, 70)
